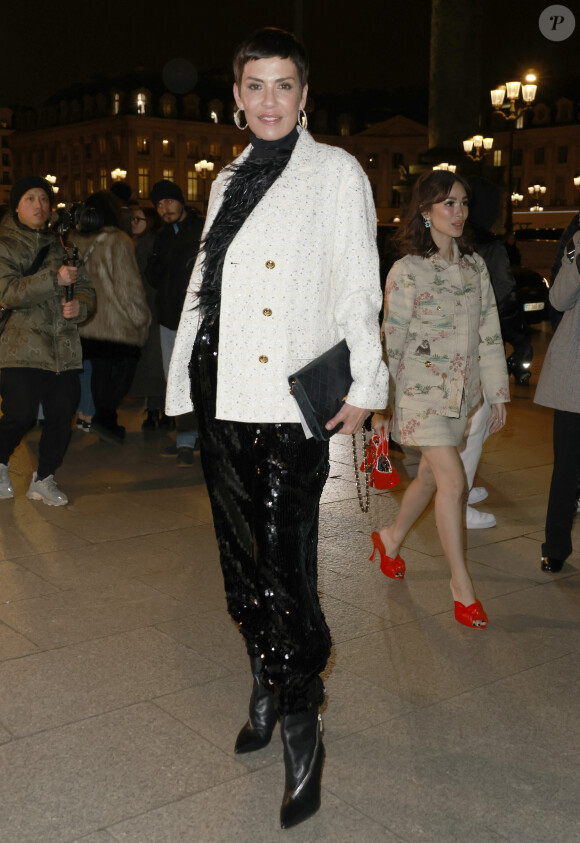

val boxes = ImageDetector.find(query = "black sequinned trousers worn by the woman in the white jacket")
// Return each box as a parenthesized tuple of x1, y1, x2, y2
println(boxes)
(190, 317, 331, 715)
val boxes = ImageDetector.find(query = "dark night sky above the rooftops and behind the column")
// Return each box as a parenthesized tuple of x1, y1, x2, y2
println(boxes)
(0, 0, 580, 110)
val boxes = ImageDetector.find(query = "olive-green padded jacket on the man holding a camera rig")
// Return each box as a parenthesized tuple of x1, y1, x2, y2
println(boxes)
(0, 214, 96, 372)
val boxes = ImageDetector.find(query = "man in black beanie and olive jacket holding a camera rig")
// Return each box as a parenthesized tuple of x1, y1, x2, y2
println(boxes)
(0, 176, 95, 506)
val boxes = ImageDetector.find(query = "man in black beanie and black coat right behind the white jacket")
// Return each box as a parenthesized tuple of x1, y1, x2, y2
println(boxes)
(145, 179, 203, 466)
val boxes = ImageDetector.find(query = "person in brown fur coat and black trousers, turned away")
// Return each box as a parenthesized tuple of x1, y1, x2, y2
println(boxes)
(71, 191, 151, 444)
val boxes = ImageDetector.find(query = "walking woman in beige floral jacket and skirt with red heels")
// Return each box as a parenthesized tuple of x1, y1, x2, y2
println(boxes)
(372, 170, 509, 628)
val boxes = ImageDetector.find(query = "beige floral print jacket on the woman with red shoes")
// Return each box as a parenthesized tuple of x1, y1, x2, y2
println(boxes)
(383, 243, 509, 418)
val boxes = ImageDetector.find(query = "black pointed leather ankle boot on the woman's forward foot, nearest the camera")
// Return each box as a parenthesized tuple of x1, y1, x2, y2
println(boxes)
(280, 706, 325, 828)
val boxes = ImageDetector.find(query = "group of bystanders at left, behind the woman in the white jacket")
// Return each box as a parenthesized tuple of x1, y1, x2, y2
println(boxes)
(0, 166, 203, 494)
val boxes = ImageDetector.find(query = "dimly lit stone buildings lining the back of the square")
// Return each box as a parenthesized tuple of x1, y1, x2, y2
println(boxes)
(6, 71, 580, 228)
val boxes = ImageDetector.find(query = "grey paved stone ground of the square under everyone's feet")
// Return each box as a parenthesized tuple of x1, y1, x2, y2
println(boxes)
(0, 320, 580, 843)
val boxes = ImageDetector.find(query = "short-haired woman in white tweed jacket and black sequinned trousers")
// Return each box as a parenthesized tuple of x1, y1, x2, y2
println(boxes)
(167, 29, 387, 828)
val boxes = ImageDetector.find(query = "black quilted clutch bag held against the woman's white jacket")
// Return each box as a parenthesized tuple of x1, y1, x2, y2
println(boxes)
(288, 340, 352, 441)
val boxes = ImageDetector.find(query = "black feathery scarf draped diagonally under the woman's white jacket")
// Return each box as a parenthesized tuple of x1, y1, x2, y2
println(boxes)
(197, 147, 292, 319)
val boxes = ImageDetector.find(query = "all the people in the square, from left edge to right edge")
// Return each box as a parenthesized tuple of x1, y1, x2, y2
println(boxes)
(0, 28, 580, 828)
